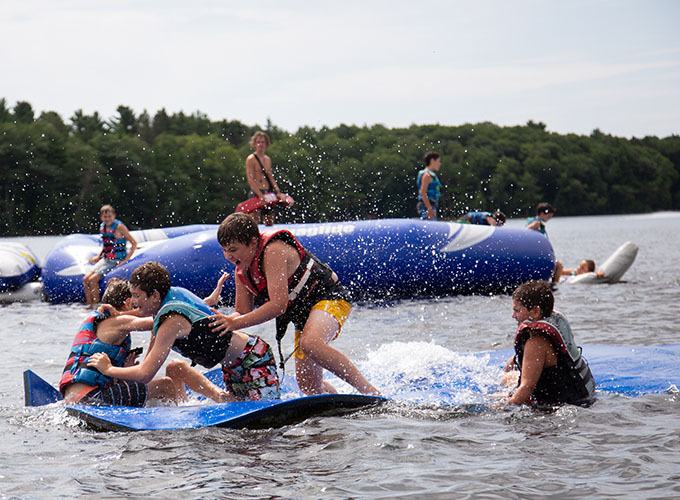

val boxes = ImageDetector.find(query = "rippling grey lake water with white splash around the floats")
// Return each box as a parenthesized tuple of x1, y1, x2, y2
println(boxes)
(0, 213, 680, 499)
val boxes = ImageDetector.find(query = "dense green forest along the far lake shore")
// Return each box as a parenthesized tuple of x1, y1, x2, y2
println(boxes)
(0, 99, 680, 236)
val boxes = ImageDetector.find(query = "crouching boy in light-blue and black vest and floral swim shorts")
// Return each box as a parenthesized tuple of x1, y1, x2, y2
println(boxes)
(88, 262, 280, 402)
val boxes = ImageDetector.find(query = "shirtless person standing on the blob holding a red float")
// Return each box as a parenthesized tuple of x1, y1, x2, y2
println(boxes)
(246, 131, 283, 226)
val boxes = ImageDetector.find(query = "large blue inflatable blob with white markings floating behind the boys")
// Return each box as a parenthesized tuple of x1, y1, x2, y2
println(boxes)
(43, 219, 555, 302)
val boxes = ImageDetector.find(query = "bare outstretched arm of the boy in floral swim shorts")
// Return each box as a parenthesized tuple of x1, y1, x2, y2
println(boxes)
(87, 314, 191, 384)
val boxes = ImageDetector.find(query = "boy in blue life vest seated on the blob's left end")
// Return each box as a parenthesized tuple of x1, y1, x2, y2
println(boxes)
(83, 205, 137, 308)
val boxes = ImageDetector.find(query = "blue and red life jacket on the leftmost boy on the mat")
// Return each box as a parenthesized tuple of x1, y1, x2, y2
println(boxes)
(59, 312, 131, 395)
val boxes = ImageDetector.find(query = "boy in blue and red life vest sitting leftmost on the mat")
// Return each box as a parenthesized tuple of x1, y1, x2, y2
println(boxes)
(59, 278, 226, 407)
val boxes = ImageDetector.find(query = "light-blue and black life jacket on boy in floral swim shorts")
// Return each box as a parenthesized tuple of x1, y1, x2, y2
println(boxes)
(151, 286, 231, 368)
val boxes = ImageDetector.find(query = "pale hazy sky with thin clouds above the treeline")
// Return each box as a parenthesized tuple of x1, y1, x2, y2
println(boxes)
(0, 0, 680, 138)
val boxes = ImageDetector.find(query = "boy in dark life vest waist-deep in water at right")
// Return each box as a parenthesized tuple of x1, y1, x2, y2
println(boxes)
(504, 281, 595, 405)
